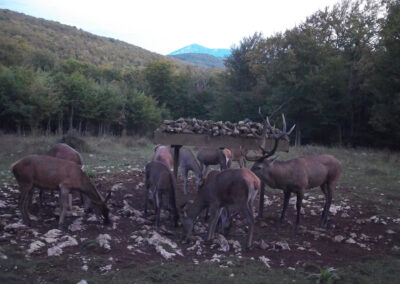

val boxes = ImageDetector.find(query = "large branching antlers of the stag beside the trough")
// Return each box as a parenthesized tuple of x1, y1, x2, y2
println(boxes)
(245, 108, 296, 161)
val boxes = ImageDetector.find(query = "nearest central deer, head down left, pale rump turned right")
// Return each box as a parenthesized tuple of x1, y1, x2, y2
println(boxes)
(181, 169, 261, 248)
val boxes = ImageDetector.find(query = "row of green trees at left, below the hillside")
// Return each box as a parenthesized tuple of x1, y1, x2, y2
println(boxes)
(0, 57, 217, 135)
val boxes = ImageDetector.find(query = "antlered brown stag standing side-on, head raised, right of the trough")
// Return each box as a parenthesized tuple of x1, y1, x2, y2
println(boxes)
(246, 115, 342, 231)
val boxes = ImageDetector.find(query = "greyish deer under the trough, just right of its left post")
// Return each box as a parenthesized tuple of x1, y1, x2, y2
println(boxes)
(175, 147, 203, 194)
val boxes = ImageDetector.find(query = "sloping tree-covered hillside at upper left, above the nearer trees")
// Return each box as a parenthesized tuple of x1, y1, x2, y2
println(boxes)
(0, 9, 181, 67)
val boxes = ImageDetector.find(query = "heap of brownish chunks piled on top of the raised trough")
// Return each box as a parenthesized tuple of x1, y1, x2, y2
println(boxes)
(156, 118, 281, 138)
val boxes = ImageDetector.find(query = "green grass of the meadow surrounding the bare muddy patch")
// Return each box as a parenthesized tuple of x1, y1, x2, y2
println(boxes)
(0, 136, 400, 283)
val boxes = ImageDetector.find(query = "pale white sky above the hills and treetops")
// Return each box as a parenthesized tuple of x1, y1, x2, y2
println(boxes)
(0, 0, 340, 55)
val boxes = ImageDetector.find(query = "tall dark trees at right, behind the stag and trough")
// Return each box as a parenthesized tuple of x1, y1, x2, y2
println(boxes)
(218, 0, 400, 148)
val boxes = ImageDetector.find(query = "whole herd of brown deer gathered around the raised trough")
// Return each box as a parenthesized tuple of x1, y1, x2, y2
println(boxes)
(11, 115, 341, 248)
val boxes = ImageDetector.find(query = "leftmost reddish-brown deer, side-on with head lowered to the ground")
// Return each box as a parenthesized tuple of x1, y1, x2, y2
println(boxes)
(11, 155, 111, 227)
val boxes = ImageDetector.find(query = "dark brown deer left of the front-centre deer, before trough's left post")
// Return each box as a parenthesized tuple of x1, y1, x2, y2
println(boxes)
(144, 161, 179, 228)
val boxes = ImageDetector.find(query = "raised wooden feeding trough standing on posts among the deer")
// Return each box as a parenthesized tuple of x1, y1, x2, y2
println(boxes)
(153, 118, 289, 217)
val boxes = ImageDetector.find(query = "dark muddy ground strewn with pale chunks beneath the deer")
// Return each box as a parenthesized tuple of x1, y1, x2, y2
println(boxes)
(0, 171, 400, 278)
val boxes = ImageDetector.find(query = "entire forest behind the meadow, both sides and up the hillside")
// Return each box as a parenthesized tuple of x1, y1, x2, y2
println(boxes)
(0, 0, 400, 149)
